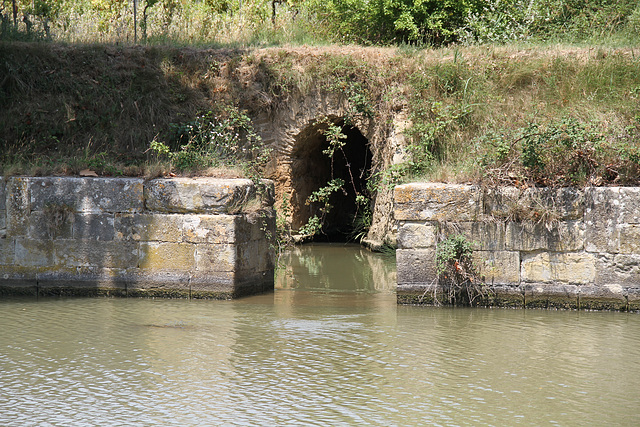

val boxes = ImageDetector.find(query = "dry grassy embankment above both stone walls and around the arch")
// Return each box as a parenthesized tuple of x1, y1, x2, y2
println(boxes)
(0, 43, 640, 185)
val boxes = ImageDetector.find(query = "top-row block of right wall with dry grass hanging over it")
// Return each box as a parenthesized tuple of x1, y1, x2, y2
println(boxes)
(483, 187, 585, 221)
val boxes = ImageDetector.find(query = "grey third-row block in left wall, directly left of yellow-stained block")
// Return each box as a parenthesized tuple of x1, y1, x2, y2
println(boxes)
(51, 239, 139, 270)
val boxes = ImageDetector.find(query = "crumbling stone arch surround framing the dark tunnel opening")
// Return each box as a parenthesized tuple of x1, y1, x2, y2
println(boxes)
(254, 92, 408, 247)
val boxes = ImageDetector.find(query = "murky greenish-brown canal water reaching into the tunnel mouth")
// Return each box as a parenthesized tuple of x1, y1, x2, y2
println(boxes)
(0, 245, 640, 426)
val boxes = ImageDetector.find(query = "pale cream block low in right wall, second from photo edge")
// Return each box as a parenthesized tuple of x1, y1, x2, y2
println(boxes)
(520, 252, 596, 284)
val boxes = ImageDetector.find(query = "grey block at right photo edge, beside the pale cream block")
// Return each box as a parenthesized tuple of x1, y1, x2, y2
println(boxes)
(595, 253, 640, 288)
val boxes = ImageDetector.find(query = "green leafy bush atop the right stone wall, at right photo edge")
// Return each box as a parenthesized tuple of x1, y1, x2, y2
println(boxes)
(480, 117, 640, 186)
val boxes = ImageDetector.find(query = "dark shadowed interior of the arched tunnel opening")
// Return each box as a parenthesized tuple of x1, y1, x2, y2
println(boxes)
(290, 116, 373, 241)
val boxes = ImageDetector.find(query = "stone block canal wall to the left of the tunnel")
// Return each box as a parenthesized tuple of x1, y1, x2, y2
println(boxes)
(0, 177, 275, 298)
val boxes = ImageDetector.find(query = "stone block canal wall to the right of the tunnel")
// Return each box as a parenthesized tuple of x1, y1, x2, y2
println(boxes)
(394, 183, 640, 310)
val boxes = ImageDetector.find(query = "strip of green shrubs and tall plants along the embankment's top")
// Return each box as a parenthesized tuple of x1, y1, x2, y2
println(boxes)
(0, 0, 640, 46)
